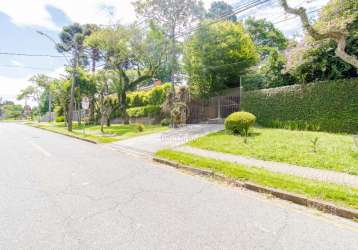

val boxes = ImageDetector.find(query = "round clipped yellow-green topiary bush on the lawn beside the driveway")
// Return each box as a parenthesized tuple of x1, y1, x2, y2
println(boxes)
(225, 112, 256, 136)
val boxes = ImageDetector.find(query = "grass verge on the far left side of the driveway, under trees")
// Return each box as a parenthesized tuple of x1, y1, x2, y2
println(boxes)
(30, 123, 168, 143)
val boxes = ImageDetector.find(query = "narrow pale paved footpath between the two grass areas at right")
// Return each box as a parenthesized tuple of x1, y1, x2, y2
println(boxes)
(176, 146, 358, 188)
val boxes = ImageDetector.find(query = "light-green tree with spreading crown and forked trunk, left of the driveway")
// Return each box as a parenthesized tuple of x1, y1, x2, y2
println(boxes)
(88, 25, 162, 124)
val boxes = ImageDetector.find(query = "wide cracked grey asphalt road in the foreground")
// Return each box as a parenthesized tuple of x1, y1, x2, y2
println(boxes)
(0, 123, 358, 250)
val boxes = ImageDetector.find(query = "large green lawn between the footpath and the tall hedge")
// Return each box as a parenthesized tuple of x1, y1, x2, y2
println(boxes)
(189, 128, 358, 175)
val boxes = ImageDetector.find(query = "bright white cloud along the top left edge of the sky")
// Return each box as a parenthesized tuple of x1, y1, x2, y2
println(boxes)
(0, 0, 135, 30)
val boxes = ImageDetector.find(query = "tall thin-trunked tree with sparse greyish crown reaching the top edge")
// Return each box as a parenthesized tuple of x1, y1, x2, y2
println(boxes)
(134, 0, 205, 84)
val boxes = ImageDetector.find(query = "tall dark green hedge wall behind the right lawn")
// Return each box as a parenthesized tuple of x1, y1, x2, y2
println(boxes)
(241, 78, 358, 133)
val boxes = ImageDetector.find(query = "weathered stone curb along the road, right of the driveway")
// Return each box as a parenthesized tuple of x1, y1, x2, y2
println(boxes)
(153, 157, 358, 220)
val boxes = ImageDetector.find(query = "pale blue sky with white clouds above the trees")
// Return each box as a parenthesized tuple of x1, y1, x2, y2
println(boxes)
(0, 0, 328, 103)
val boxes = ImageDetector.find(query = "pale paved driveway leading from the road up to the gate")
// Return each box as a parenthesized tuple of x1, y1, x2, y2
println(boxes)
(111, 124, 224, 156)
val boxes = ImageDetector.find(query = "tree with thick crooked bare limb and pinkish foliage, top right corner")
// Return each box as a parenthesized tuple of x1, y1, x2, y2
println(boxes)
(280, 0, 358, 70)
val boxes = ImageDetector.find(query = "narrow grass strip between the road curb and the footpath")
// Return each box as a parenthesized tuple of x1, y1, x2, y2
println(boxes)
(156, 150, 358, 209)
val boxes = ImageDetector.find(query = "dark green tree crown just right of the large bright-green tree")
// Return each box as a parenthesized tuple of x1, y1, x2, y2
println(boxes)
(245, 17, 288, 59)
